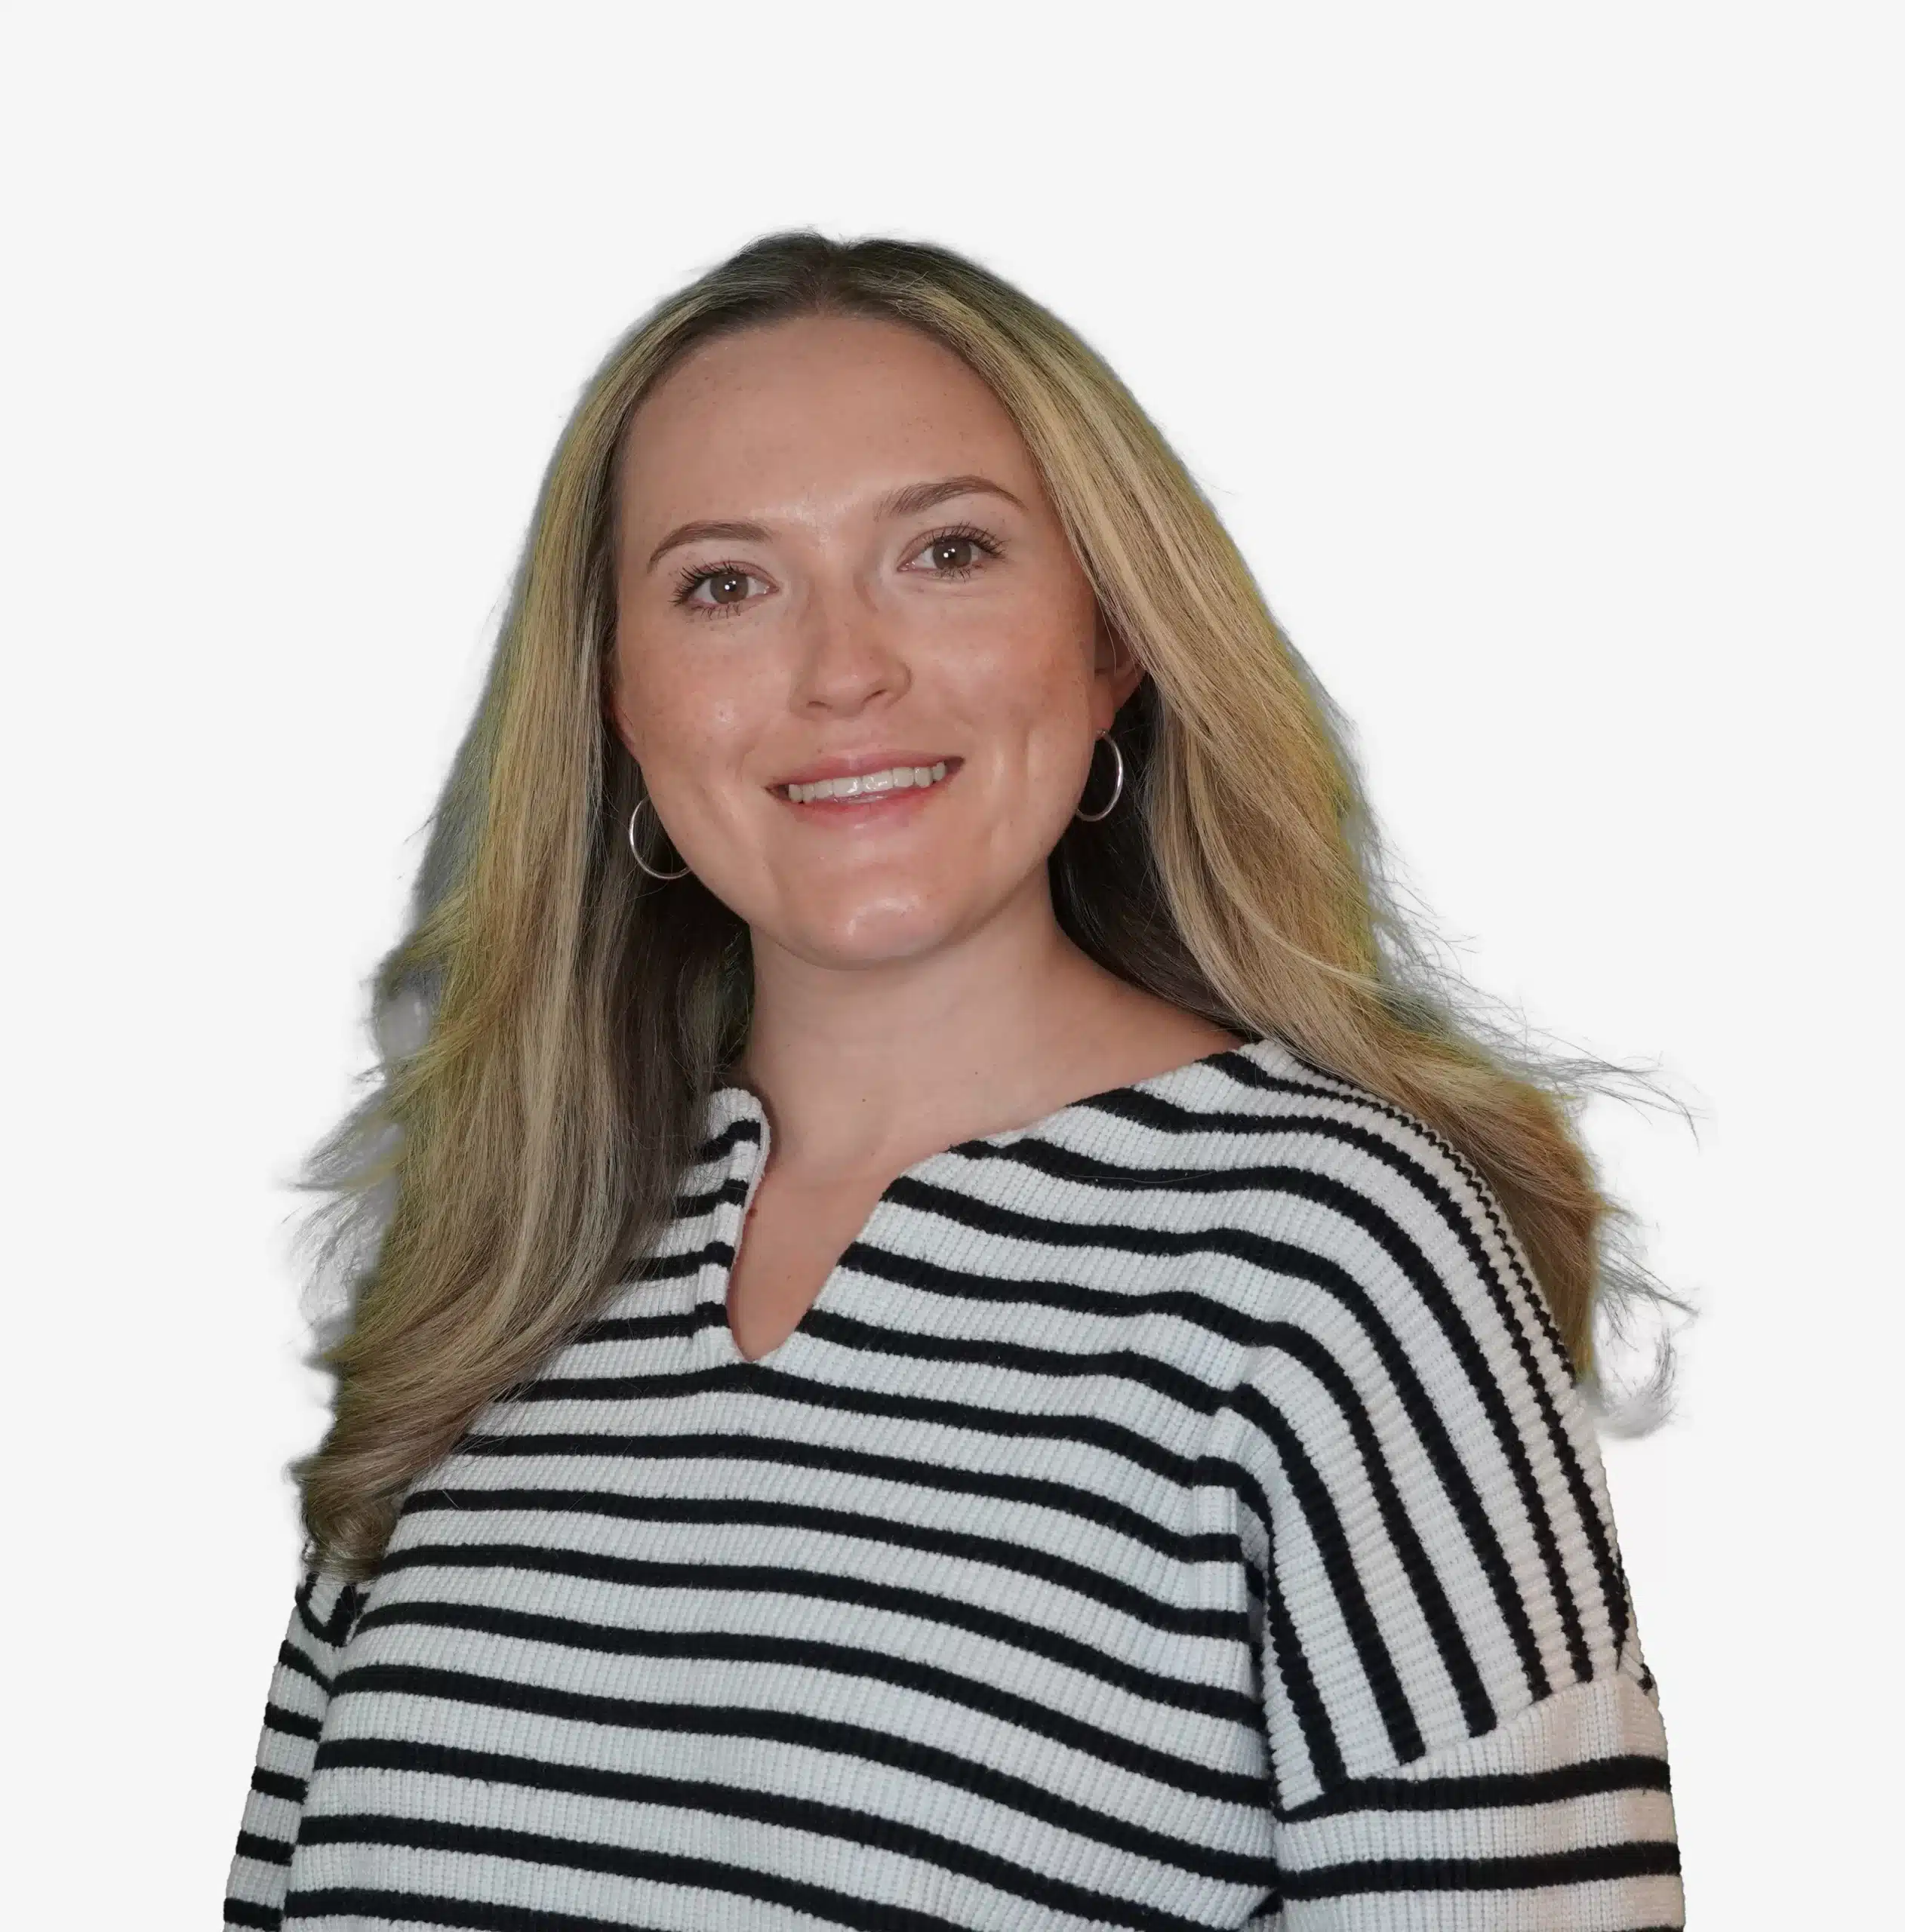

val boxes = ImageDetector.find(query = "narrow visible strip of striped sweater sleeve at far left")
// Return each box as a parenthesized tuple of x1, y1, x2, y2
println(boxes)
(224, 1569, 362, 1932)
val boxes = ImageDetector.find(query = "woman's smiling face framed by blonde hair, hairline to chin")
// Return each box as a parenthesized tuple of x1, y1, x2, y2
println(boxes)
(608, 317, 1140, 966)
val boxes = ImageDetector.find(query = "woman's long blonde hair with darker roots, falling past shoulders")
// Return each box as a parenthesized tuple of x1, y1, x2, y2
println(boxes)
(296, 232, 1671, 1577)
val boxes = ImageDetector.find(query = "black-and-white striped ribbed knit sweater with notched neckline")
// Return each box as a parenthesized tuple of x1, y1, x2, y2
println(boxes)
(224, 1039, 1683, 1932)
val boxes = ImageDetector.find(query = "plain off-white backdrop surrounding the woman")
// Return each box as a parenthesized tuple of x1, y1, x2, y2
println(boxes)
(0, 0, 1905, 1928)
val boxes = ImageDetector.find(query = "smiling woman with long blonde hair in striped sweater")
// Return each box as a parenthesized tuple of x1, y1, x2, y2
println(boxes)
(226, 234, 1681, 1928)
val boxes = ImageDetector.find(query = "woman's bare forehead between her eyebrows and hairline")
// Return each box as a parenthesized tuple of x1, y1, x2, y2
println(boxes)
(620, 315, 1039, 524)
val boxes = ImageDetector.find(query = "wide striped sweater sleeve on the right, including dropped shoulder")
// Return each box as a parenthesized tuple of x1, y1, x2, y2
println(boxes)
(1214, 1109, 1685, 1932)
